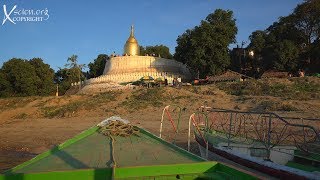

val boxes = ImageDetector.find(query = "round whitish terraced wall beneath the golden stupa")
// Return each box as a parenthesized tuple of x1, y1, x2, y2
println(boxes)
(85, 56, 191, 84)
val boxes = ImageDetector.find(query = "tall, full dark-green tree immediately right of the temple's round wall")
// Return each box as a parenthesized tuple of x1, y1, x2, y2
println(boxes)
(174, 9, 238, 77)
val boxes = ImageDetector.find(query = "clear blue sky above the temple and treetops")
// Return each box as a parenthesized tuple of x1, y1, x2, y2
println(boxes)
(0, 0, 303, 70)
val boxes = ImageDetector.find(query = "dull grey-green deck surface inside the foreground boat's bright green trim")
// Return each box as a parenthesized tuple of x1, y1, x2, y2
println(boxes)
(8, 127, 205, 173)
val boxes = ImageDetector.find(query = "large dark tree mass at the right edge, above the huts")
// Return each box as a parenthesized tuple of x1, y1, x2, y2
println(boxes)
(248, 0, 320, 73)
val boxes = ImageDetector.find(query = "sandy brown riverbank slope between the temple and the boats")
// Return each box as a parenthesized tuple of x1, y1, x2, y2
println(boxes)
(0, 78, 320, 172)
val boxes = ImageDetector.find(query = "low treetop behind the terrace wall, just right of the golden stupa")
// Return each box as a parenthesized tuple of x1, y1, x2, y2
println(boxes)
(140, 44, 173, 59)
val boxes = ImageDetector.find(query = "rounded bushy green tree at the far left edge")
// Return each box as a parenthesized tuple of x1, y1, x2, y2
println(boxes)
(0, 58, 54, 97)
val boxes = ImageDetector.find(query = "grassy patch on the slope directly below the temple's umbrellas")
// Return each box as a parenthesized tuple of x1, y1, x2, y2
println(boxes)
(121, 88, 165, 110)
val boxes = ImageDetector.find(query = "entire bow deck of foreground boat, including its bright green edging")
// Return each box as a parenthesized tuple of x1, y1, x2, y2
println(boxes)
(0, 127, 255, 180)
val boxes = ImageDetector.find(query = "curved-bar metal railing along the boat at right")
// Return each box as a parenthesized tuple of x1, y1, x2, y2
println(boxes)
(193, 109, 320, 159)
